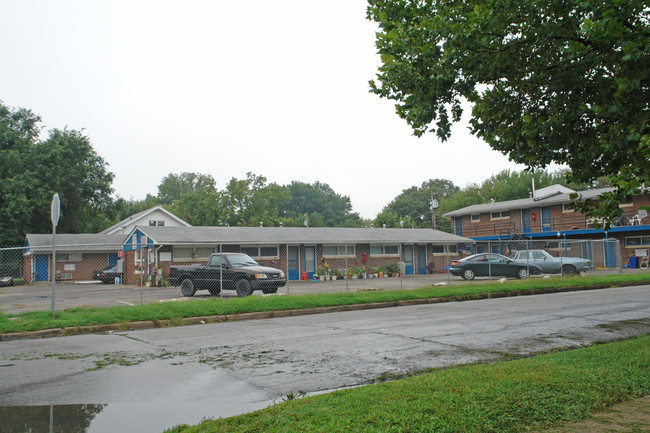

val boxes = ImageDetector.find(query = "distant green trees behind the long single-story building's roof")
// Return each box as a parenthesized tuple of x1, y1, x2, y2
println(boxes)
(115, 172, 363, 227)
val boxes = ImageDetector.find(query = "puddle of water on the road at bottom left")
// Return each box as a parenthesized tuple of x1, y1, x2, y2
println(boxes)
(0, 401, 274, 433)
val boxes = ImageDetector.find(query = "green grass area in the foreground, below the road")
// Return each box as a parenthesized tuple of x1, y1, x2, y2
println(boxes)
(167, 336, 650, 433)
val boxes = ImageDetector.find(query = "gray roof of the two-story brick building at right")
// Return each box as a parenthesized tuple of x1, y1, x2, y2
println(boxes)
(444, 188, 613, 217)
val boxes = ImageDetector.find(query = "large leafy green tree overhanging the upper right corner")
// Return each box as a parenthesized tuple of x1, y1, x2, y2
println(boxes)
(368, 0, 650, 221)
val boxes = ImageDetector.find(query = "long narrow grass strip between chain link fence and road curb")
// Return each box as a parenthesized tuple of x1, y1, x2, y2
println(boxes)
(0, 272, 650, 333)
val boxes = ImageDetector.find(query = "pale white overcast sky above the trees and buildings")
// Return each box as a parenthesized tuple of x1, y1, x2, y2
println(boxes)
(0, 0, 524, 218)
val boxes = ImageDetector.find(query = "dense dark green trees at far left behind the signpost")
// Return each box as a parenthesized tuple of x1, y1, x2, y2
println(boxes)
(0, 103, 113, 246)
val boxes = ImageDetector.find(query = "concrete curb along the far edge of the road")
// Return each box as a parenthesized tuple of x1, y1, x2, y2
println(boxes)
(0, 281, 650, 341)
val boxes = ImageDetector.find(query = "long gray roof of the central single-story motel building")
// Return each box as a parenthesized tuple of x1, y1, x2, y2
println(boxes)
(137, 226, 474, 245)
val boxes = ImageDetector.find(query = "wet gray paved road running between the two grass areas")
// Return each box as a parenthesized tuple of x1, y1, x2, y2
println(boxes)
(0, 286, 650, 431)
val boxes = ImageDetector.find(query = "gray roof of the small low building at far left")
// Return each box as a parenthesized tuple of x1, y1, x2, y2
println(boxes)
(25, 233, 125, 252)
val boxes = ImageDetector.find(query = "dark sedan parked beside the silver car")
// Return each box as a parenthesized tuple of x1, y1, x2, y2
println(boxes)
(449, 253, 542, 280)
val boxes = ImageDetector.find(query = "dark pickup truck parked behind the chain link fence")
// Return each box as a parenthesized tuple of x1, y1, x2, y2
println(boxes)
(169, 253, 287, 296)
